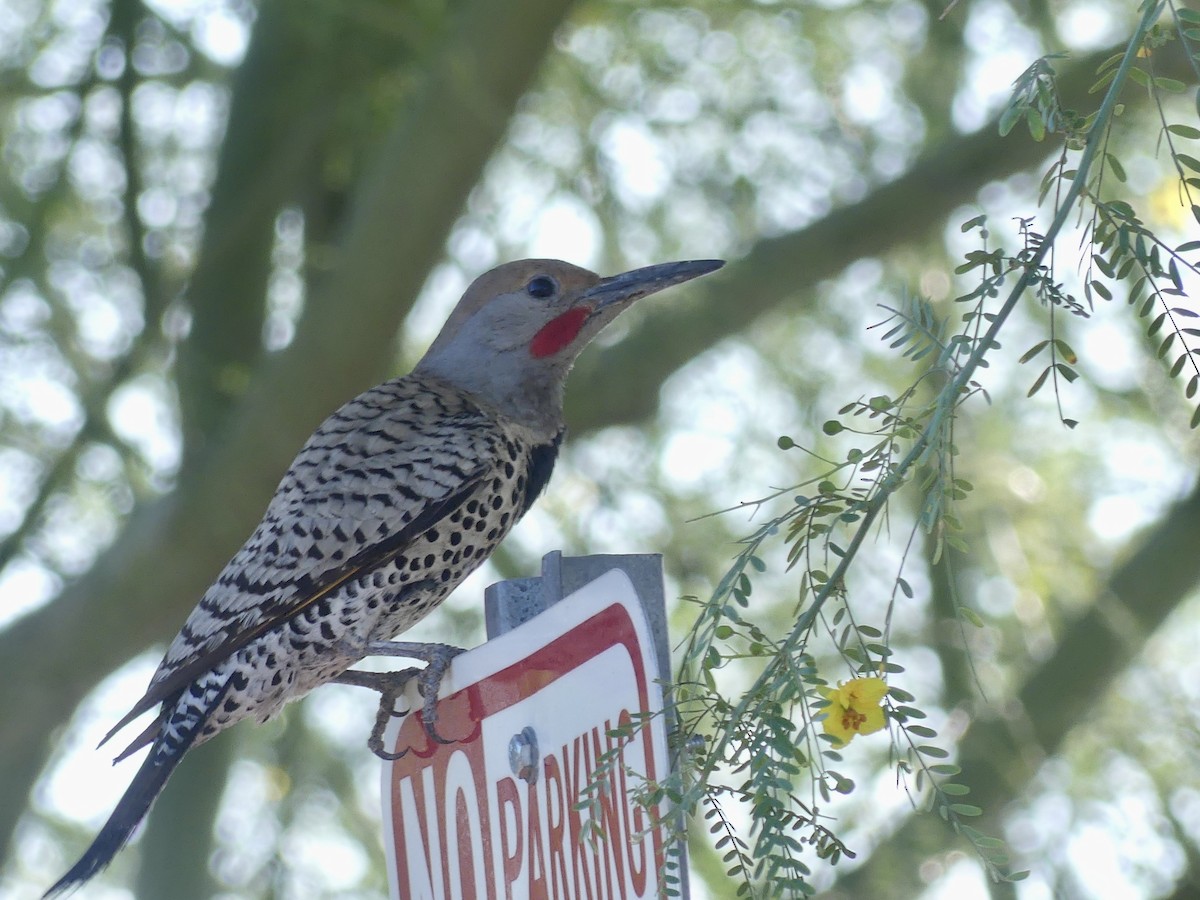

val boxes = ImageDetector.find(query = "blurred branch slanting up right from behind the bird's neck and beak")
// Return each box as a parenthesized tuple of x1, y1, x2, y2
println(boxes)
(566, 41, 1195, 431)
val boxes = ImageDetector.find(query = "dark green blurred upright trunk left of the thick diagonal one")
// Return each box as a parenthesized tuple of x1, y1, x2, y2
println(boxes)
(171, 2, 324, 467)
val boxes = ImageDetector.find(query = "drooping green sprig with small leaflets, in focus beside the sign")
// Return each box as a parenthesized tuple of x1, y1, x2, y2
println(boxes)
(609, 2, 1200, 896)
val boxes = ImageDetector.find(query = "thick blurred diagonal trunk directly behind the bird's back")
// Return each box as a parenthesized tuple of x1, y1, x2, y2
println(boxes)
(0, 0, 570, 864)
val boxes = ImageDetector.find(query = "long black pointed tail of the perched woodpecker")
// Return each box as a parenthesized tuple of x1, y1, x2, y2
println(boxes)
(42, 670, 230, 900)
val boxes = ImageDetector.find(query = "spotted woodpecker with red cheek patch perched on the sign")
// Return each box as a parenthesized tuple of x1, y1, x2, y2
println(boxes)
(46, 259, 724, 898)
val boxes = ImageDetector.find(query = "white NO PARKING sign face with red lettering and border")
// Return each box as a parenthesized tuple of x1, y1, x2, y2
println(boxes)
(383, 570, 668, 900)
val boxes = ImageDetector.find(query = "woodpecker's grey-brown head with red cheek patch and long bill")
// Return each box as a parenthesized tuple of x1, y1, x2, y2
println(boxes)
(416, 259, 724, 431)
